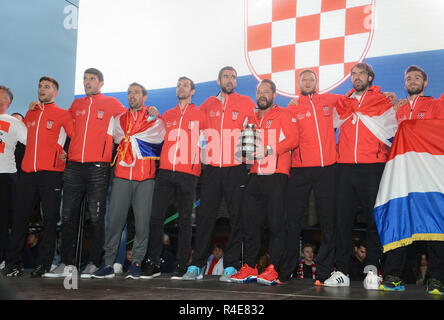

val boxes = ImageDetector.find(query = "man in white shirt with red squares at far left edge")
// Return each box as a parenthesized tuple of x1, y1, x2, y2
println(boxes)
(0, 86, 27, 268)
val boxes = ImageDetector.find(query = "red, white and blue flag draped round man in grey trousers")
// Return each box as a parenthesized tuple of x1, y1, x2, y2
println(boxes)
(113, 106, 165, 167)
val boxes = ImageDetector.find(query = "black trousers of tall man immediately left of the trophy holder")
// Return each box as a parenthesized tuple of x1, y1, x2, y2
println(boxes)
(191, 164, 248, 269)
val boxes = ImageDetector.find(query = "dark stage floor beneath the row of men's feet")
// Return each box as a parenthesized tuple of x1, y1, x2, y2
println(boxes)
(0, 272, 444, 301)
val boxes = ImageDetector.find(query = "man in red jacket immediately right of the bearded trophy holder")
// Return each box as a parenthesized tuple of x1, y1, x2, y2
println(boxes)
(279, 70, 339, 282)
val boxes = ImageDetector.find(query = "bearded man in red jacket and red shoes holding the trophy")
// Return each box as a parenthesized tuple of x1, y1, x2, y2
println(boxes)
(231, 79, 299, 285)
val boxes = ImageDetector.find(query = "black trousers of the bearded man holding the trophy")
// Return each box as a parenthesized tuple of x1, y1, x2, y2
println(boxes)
(241, 173, 288, 269)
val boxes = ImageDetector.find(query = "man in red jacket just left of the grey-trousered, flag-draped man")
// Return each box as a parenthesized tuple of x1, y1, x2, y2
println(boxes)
(44, 68, 126, 278)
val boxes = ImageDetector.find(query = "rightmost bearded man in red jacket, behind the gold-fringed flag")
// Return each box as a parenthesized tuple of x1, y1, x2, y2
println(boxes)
(379, 65, 444, 295)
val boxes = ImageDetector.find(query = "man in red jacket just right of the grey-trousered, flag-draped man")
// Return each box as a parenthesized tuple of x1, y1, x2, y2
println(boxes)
(141, 77, 205, 279)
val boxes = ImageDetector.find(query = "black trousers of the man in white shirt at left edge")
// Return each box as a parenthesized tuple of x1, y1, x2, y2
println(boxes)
(0, 173, 17, 261)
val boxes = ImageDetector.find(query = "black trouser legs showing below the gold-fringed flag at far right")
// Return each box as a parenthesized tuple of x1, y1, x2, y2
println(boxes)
(382, 241, 444, 283)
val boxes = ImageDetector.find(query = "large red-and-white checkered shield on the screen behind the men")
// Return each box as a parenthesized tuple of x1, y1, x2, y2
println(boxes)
(244, 0, 375, 97)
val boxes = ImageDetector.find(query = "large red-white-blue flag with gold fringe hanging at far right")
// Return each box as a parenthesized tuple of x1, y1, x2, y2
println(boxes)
(373, 120, 444, 252)
